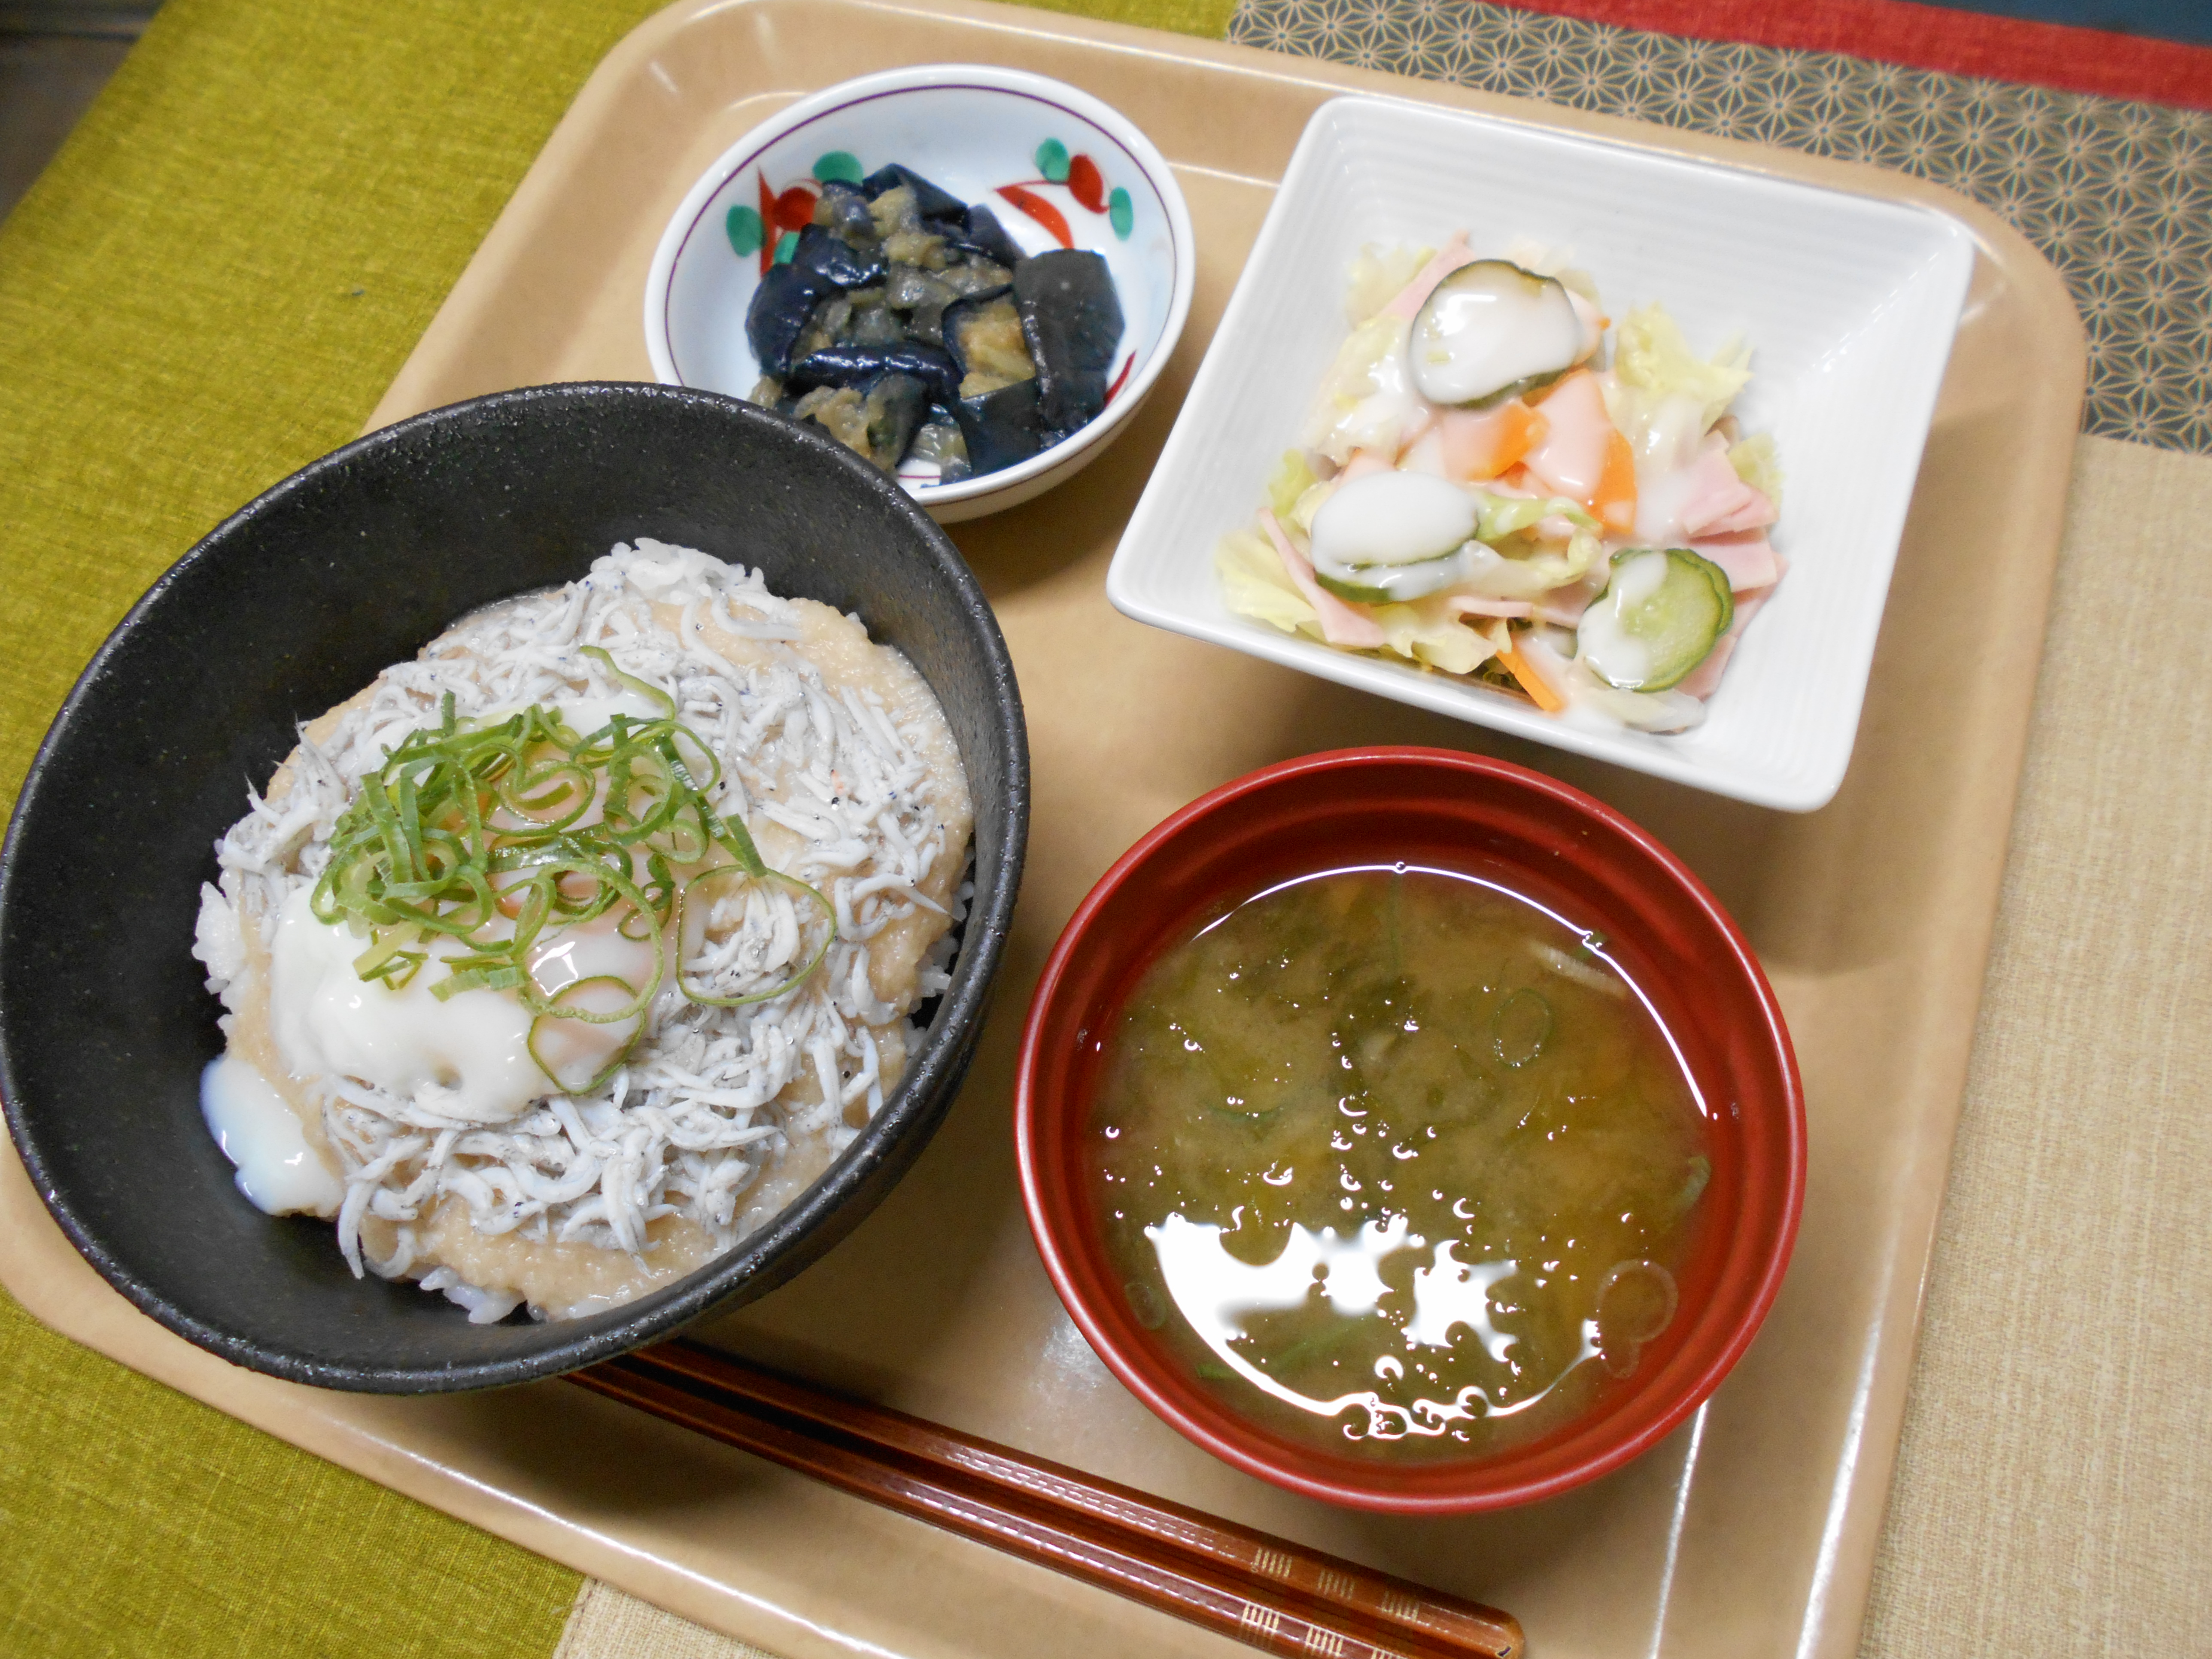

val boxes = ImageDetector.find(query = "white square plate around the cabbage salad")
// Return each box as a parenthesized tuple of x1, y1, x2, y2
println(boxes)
(1106, 97, 1973, 812)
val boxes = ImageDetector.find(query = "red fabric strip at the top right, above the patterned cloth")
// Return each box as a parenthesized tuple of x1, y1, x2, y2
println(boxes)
(1511, 0, 2212, 111)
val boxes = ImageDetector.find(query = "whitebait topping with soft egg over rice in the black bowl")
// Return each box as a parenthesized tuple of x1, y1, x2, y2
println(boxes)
(194, 542, 969, 1319)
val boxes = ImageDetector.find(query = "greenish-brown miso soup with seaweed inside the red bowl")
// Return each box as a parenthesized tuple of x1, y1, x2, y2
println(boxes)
(1088, 865, 1712, 1458)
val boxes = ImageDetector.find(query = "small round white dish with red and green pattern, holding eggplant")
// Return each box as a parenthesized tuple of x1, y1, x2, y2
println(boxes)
(644, 64, 1197, 524)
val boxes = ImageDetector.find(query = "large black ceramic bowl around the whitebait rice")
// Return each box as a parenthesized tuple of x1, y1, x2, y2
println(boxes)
(0, 385, 1029, 1394)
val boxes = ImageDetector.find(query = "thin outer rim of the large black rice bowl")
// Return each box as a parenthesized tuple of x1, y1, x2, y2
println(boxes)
(0, 380, 1031, 1394)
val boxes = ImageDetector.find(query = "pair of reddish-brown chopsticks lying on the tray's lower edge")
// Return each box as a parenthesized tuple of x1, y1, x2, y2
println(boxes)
(571, 1343, 1524, 1659)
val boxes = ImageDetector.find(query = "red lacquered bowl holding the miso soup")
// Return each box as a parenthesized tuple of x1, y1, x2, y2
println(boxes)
(1015, 747, 1805, 1515)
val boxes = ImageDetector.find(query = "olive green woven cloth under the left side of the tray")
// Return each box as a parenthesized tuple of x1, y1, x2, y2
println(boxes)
(0, 0, 1230, 1659)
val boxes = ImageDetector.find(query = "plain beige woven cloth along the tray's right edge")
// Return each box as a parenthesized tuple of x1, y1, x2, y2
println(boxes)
(1863, 438, 2212, 1659)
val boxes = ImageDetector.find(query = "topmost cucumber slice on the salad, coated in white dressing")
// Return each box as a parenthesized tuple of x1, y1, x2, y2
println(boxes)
(1405, 259, 1584, 405)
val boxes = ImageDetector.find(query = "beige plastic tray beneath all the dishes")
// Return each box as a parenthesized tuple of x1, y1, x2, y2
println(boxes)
(0, 0, 2084, 1659)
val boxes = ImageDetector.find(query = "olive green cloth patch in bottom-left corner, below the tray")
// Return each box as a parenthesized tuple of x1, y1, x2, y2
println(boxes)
(0, 1294, 577, 1659)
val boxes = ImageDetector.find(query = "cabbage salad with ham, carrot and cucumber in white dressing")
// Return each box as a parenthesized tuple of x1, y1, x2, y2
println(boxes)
(1214, 232, 1785, 732)
